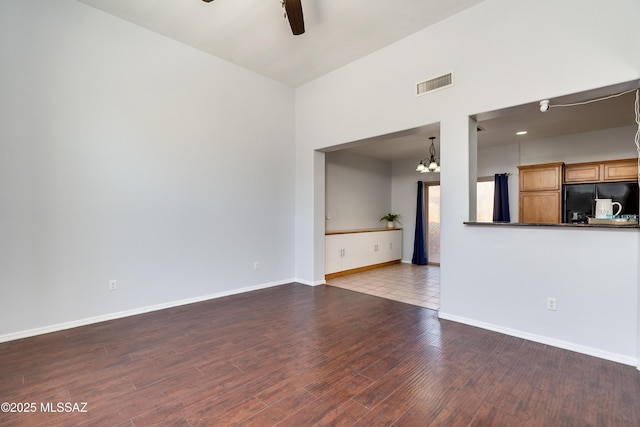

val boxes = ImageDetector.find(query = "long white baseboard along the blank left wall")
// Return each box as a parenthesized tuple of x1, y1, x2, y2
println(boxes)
(0, 279, 296, 343)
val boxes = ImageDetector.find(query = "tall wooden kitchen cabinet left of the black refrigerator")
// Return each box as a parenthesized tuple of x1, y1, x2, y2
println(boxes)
(518, 162, 564, 224)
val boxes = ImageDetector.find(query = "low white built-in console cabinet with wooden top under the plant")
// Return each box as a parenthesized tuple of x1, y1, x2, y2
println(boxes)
(325, 228, 402, 278)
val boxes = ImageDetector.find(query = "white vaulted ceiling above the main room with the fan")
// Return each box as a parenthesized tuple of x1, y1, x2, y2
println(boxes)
(79, 0, 482, 87)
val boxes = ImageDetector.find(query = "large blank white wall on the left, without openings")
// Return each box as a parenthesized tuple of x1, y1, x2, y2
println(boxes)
(0, 0, 295, 340)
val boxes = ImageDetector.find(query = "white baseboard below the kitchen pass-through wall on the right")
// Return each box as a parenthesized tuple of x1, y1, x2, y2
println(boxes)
(438, 311, 640, 370)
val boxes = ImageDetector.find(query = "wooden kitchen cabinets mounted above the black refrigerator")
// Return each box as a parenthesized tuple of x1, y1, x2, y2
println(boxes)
(564, 159, 638, 184)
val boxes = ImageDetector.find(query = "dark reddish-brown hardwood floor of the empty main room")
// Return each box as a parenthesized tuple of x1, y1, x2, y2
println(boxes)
(0, 284, 640, 427)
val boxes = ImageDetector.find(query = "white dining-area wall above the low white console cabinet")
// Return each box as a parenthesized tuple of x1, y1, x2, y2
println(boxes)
(325, 151, 391, 231)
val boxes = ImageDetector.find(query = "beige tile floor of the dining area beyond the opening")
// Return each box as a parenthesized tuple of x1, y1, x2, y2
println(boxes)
(327, 264, 440, 310)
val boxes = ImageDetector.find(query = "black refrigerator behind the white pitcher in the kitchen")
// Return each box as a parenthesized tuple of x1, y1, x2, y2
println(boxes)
(562, 182, 640, 223)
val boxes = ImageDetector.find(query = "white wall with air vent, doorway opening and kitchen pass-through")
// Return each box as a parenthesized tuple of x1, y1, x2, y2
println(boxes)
(296, 0, 640, 363)
